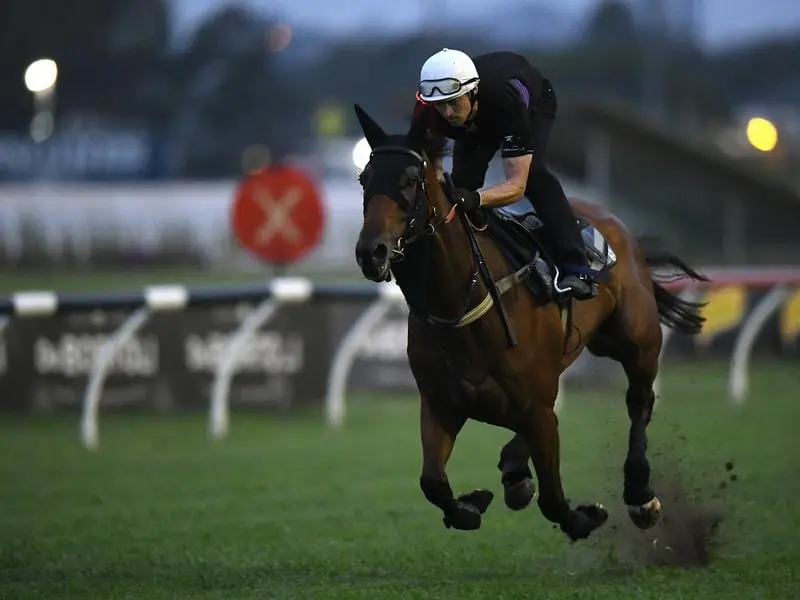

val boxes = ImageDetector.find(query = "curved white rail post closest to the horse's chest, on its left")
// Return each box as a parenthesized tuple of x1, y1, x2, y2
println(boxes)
(325, 282, 404, 427)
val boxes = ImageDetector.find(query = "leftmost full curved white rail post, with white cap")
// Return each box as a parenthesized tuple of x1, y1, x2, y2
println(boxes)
(81, 285, 188, 450)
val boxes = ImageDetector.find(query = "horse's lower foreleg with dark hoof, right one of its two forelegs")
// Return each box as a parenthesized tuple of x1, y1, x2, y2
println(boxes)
(525, 405, 608, 540)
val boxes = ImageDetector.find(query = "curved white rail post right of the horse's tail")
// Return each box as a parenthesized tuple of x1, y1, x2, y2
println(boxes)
(728, 284, 791, 405)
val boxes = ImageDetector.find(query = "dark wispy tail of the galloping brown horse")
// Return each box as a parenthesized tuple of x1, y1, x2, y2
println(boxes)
(637, 237, 708, 335)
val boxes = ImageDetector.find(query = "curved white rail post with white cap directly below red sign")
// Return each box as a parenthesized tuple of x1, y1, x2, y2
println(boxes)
(209, 277, 314, 440)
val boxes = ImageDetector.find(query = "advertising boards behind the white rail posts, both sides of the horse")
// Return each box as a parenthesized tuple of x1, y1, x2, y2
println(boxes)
(0, 283, 800, 412)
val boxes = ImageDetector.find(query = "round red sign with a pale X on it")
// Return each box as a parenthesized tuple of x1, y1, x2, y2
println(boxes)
(231, 165, 325, 264)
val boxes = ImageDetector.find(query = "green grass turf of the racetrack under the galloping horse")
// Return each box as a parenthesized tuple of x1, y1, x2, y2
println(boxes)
(0, 367, 800, 600)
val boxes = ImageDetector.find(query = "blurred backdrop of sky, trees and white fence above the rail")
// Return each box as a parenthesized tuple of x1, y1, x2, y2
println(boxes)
(0, 0, 800, 277)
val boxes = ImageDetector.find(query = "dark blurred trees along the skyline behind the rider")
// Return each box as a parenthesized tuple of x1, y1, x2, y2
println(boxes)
(0, 0, 800, 176)
